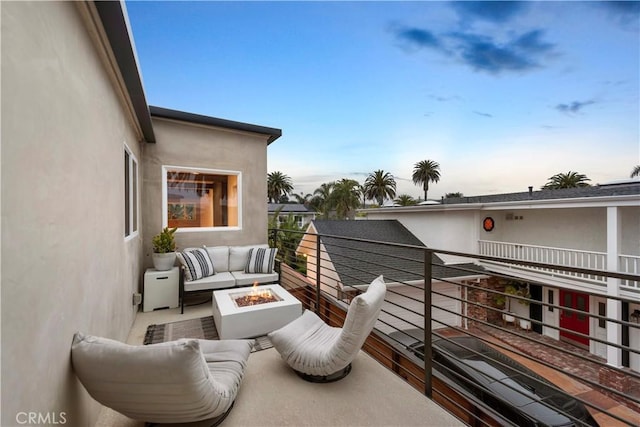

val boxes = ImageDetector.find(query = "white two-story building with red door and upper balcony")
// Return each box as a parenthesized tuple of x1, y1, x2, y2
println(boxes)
(362, 181, 640, 371)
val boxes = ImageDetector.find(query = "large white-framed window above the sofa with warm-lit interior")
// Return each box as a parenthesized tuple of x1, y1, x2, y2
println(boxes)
(163, 166, 241, 229)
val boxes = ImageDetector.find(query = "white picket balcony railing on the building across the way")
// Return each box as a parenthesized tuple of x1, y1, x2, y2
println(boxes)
(478, 240, 608, 284)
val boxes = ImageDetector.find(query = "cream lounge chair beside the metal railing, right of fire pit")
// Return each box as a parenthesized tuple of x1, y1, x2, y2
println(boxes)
(269, 276, 387, 382)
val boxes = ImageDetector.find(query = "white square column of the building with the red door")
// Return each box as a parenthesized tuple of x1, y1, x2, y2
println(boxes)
(607, 206, 622, 367)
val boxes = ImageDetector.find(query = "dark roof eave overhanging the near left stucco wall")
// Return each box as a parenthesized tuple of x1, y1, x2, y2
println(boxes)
(93, 0, 156, 143)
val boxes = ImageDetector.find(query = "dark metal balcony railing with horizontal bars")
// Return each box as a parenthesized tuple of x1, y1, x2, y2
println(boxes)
(270, 229, 640, 425)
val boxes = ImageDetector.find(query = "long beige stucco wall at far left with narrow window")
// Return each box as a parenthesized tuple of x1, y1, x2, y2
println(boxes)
(1, 2, 142, 426)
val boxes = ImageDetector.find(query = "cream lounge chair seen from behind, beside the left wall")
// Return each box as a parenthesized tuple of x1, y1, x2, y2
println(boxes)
(71, 332, 253, 425)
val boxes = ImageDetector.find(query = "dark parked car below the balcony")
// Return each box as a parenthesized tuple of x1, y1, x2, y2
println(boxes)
(389, 329, 598, 426)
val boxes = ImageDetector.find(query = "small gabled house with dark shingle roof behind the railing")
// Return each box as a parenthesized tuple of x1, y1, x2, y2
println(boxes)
(297, 220, 486, 333)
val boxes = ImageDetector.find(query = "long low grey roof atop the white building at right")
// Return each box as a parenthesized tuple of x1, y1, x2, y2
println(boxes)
(442, 181, 640, 205)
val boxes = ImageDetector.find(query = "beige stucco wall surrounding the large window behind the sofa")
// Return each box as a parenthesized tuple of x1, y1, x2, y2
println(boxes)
(142, 118, 267, 267)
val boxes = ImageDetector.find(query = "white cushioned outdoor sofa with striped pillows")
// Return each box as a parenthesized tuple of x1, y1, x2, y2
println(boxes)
(178, 244, 279, 313)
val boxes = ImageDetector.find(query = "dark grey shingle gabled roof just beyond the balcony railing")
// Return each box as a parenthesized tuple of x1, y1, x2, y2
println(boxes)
(312, 219, 484, 286)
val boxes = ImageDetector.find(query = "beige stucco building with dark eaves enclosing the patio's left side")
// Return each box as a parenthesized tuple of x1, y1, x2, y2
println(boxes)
(0, 1, 281, 426)
